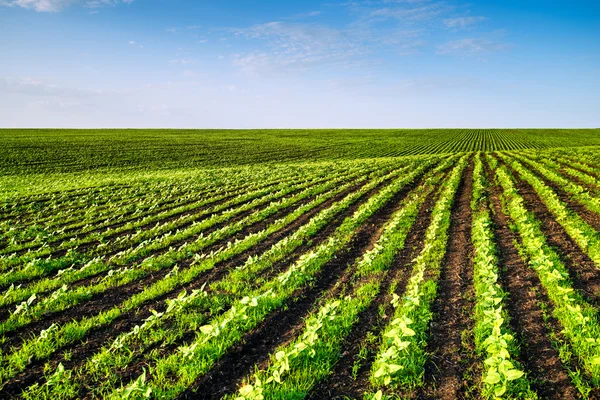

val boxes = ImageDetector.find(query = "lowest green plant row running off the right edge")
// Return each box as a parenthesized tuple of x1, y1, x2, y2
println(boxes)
(496, 159, 600, 385)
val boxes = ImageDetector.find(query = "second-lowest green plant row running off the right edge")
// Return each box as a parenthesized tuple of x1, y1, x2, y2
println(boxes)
(502, 156, 600, 266)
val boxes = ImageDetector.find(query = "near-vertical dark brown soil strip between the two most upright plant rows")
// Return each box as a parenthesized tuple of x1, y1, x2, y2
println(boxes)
(418, 161, 475, 399)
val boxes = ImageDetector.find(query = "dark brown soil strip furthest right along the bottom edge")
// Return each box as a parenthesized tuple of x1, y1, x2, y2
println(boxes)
(486, 158, 578, 399)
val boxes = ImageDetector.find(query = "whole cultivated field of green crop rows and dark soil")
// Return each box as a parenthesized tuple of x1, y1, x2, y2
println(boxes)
(0, 129, 600, 400)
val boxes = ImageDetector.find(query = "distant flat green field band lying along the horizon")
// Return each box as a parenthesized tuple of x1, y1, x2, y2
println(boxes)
(0, 129, 600, 175)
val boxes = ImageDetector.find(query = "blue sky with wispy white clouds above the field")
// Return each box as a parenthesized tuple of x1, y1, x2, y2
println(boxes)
(0, 0, 600, 128)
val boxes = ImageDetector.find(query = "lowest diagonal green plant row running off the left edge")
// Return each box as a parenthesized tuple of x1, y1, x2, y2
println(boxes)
(0, 159, 426, 385)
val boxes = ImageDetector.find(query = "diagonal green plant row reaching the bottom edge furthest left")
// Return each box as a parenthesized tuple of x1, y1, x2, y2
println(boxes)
(18, 155, 436, 398)
